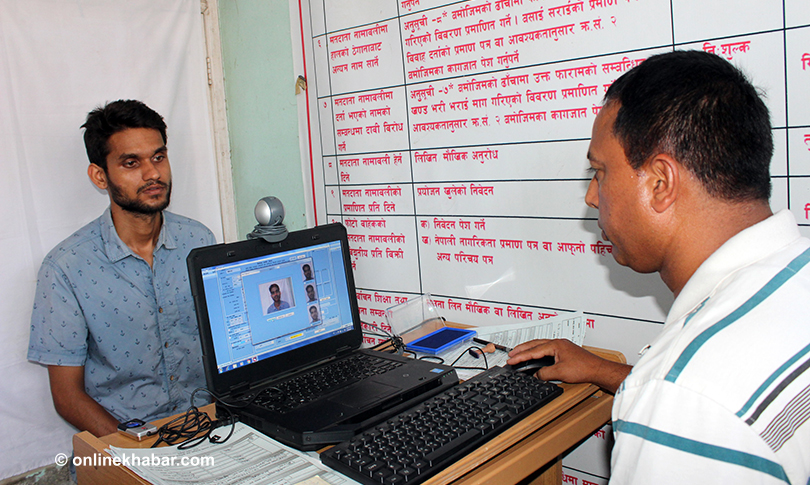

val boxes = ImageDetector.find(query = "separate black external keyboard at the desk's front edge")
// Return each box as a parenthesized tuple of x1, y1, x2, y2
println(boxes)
(321, 367, 563, 485)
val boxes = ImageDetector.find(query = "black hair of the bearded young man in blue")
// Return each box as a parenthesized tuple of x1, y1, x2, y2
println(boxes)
(82, 99, 167, 172)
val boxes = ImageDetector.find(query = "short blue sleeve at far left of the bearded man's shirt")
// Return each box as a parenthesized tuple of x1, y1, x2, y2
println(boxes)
(28, 259, 88, 366)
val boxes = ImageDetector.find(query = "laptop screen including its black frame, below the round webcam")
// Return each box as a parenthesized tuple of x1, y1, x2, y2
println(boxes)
(188, 224, 362, 394)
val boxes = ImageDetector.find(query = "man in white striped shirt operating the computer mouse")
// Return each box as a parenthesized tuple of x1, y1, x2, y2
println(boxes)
(509, 51, 810, 485)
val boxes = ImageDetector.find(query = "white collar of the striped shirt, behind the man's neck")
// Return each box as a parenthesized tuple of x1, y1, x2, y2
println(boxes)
(666, 209, 801, 324)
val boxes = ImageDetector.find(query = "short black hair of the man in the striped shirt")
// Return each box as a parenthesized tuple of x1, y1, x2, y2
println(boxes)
(605, 51, 773, 201)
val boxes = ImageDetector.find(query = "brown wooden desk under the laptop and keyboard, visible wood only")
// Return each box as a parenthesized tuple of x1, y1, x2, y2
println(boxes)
(73, 347, 625, 485)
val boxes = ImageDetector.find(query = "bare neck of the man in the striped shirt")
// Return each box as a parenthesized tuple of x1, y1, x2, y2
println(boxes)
(660, 200, 773, 298)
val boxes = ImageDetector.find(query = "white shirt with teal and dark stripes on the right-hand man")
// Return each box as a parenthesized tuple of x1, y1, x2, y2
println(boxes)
(611, 211, 810, 485)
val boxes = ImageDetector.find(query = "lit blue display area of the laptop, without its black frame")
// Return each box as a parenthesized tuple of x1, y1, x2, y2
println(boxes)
(202, 241, 354, 373)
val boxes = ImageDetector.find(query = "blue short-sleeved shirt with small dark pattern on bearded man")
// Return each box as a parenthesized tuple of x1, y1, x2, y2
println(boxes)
(28, 208, 216, 421)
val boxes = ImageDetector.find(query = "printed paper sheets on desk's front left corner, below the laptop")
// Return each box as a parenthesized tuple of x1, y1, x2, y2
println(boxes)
(108, 423, 357, 485)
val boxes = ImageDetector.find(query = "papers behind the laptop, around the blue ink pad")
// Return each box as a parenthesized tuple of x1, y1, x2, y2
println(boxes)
(422, 312, 586, 380)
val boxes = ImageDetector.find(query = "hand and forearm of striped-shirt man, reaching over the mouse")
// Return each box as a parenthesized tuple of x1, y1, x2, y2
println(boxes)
(507, 339, 633, 393)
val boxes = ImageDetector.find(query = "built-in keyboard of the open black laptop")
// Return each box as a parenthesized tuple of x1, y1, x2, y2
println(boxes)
(254, 353, 402, 414)
